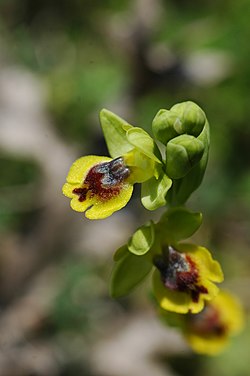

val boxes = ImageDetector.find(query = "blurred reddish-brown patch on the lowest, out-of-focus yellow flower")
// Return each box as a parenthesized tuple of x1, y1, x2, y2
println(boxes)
(187, 304, 227, 337)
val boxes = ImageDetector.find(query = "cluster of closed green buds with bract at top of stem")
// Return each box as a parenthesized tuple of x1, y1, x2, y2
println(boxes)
(152, 101, 210, 204)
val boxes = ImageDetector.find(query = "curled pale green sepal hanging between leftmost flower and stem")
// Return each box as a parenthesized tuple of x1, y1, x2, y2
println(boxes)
(141, 171, 172, 210)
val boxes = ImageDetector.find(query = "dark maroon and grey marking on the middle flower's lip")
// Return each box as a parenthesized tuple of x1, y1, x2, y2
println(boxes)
(155, 247, 208, 303)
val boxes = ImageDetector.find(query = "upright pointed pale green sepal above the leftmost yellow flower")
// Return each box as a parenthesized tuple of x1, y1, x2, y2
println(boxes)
(100, 109, 133, 158)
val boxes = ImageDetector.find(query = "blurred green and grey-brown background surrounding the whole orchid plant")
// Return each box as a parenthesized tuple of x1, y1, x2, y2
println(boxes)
(0, 0, 250, 376)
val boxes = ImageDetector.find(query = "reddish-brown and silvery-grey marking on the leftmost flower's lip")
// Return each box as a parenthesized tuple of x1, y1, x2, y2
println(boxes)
(72, 157, 130, 202)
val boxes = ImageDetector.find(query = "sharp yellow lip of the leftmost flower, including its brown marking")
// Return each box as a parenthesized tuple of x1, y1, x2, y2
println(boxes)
(63, 155, 133, 219)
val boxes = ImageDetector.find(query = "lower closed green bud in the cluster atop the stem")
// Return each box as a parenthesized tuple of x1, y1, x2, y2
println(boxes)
(166, 134, 204, 179)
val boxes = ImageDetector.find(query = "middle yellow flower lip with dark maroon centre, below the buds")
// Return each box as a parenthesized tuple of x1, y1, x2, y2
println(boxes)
(153, 244, 223, 313)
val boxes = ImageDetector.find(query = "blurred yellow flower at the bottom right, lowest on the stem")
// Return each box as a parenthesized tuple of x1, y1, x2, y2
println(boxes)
(184, 291, 244, 355)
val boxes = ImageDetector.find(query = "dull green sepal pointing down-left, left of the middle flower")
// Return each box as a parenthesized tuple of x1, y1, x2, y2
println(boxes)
(110, 250, 153, 298)
